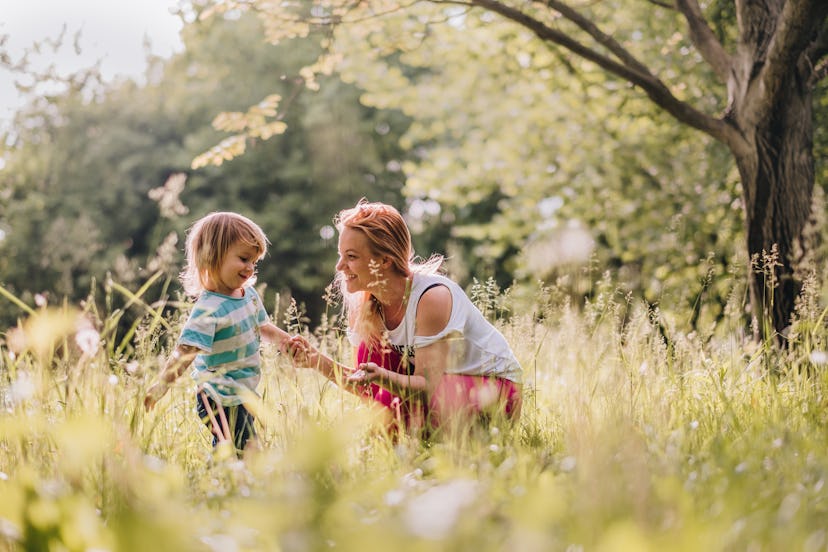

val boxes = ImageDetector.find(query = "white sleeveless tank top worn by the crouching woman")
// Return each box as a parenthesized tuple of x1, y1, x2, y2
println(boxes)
(349, 273, 523, 383)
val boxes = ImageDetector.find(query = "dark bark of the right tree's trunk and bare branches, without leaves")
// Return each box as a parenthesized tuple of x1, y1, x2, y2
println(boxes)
(482, 0, 828, 338)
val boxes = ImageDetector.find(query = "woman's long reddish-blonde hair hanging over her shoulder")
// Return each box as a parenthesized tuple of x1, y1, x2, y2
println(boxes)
(334, 198, 443, 346)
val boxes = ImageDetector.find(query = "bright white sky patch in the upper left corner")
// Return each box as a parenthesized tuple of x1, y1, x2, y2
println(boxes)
(0, 0, 182, 122)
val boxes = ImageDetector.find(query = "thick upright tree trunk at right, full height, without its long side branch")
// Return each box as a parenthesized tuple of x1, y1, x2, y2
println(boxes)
(724, 0, 828, 338)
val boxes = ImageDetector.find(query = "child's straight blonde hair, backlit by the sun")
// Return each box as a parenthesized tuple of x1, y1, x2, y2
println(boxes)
(181, 212, 268, 297)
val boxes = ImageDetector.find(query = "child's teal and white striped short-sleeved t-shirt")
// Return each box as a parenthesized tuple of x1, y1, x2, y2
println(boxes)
(178, 287, 267, 406)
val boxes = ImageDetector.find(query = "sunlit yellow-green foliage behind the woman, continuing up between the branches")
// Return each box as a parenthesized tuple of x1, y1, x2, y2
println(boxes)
(199, 1, 746, 318)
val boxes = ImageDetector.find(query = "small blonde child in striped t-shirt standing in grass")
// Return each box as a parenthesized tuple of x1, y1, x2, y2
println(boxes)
(144, 212, 289, 451)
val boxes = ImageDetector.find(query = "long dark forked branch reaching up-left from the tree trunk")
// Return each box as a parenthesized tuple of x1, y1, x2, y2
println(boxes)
(460, 0, 740, 145)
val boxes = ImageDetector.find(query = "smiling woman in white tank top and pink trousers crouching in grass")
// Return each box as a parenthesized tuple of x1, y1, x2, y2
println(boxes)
(289, 200, 522, 433)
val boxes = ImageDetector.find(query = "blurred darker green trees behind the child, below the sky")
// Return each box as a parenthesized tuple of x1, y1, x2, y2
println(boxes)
(0, 9, 407, 328)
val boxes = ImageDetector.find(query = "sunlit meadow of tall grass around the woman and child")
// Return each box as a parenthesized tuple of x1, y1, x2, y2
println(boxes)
(0, 272, 828, 552)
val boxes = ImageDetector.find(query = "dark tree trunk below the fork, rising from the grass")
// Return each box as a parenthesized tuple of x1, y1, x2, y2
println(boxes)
(734, 82, 814, 338)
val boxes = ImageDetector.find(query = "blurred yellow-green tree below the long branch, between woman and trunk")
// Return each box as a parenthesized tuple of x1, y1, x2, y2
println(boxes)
(330, 12, 746, 330)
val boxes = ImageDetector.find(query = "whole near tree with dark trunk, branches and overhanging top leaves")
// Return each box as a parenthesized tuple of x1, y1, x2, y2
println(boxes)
(199, 0, 828, 338)
